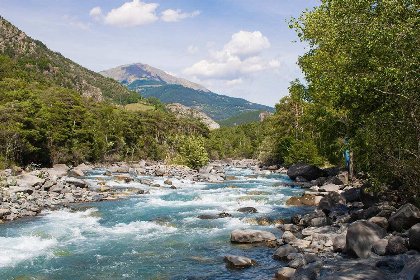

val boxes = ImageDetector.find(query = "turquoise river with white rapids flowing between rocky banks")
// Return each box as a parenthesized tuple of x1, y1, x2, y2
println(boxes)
(0, 168, 304, 279)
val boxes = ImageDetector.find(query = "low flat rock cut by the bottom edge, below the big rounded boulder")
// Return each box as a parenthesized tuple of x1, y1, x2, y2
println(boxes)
(323, 263, 392, 280)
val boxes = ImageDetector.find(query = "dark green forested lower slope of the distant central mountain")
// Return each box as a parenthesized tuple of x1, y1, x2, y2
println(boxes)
(134, 84, 273, 120)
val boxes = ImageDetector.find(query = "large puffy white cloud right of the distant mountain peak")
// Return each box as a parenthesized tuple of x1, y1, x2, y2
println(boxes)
(183, 31, 280, 86)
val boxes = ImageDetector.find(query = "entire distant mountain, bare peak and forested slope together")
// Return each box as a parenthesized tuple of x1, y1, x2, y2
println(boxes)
(100, 63, 274, 120)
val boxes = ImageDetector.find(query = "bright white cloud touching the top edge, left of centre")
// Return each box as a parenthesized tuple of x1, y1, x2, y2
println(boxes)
(89, 0, 159, 27)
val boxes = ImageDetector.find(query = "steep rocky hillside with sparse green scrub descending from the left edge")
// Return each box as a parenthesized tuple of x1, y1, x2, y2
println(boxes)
(0, 16, 141, 104)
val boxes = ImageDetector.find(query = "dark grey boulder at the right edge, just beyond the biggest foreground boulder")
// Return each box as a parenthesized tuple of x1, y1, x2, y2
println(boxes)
(388, 203, 420, 231)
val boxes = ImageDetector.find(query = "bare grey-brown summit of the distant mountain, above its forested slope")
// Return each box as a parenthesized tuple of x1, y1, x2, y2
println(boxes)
(99, 63, 209, 92)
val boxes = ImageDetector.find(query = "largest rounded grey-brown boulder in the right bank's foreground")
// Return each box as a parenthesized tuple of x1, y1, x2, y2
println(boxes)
(346, 221, 386, 259)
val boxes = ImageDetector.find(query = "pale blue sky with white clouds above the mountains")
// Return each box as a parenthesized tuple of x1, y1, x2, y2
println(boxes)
(0, 0, 319, 106)
